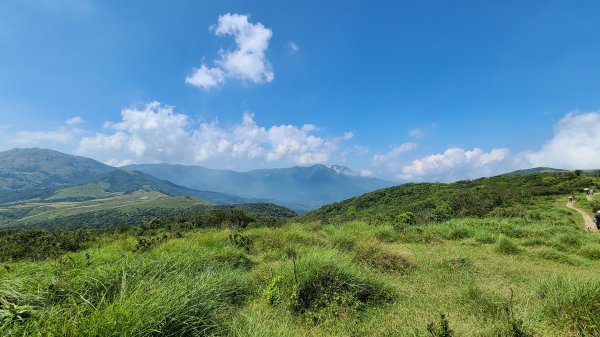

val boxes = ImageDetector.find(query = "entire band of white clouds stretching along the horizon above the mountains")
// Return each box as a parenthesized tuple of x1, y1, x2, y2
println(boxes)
(5, 107, 600, 181)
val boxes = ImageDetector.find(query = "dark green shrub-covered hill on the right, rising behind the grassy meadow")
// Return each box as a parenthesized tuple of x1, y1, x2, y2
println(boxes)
(298, 172, 600, 223)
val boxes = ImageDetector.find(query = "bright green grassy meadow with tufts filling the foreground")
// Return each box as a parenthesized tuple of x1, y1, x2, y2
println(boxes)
(0, 200, 600, 336)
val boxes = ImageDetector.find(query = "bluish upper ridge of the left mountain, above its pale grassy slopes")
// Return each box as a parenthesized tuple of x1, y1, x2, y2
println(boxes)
(0, 148, 251, 204)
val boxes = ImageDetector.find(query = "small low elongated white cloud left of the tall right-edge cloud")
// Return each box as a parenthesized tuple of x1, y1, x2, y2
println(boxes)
(397, 147, 510, 181)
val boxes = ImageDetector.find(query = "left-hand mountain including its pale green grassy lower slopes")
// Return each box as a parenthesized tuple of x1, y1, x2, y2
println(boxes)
(0, 149, 293, 228)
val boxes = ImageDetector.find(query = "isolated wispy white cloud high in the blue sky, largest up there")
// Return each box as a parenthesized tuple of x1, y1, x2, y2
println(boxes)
(186, 13, 275, 90)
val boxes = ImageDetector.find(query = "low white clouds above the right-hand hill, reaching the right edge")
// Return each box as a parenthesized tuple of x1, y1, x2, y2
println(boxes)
(394, 112, 600, 181)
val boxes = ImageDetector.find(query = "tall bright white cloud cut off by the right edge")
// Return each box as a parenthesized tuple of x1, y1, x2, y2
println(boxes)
(522, 112, 600, 169)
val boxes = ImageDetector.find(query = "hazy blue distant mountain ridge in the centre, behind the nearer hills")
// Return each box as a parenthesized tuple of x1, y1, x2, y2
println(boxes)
(126, 164, 394, 210)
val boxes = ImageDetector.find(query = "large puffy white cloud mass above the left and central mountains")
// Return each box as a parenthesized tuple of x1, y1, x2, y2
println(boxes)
(77, 102, 352, 165)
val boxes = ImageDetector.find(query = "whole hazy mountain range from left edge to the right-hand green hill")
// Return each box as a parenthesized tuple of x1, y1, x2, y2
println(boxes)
(0, 148, 393, 212)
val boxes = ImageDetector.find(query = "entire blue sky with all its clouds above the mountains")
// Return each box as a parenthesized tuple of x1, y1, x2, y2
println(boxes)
(0, 0, 600, 181)
